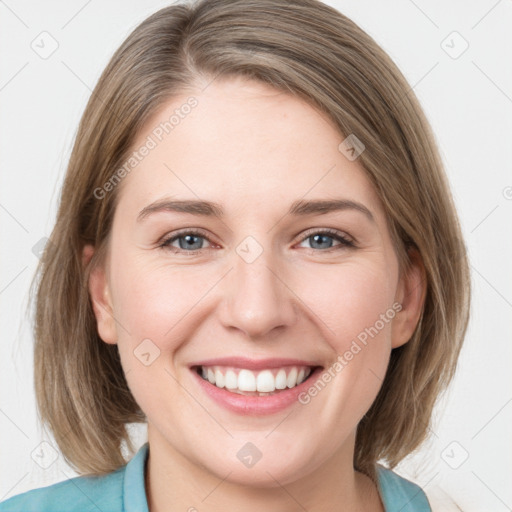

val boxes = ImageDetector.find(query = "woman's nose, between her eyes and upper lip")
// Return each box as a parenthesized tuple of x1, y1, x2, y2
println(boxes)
(220, 247, 298, 339)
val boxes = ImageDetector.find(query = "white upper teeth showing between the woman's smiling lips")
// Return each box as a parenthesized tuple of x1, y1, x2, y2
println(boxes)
(192, 365, 320, 396)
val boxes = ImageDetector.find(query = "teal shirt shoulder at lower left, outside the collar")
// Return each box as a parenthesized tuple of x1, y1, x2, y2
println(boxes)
(0, 467, 125, 512)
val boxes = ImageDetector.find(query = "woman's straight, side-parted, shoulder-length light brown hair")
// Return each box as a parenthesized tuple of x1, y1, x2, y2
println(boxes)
(31, 0, 470, 481)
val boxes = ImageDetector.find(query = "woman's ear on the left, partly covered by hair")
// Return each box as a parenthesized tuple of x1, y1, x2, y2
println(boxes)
(82, 245, 117, 344)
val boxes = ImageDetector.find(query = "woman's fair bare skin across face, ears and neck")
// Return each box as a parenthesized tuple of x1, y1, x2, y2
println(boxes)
(84, 78, 425, 512)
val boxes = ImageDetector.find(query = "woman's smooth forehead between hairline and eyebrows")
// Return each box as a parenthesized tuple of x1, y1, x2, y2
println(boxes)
(114, 78, 379, 220)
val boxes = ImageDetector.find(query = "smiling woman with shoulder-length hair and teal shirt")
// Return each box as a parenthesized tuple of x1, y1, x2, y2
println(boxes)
(0, 0, 469, 512)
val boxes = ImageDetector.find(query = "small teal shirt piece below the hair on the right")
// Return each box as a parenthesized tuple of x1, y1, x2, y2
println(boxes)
(377, 464, 432, 512)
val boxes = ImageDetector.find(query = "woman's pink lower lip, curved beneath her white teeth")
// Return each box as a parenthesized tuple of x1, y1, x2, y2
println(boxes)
(191, 367, 322, 416)
